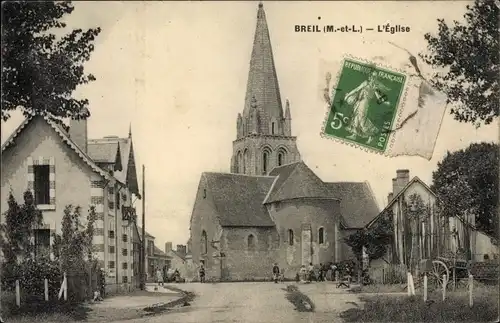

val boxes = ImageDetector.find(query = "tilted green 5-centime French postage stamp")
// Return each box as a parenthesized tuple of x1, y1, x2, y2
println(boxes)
(322, 58, 407, 154)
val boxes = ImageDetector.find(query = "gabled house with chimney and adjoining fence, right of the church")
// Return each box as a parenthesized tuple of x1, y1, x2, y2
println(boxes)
(366, 169, 498, 267)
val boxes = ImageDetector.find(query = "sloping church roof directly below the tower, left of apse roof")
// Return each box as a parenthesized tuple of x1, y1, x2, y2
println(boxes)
(203, 173, 275, 227)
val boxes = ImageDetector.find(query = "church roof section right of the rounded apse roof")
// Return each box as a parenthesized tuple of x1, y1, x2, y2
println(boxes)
(325, 182, 380, 228)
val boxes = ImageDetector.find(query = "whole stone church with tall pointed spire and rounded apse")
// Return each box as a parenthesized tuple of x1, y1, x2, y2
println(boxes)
(188, 4, 380, 280)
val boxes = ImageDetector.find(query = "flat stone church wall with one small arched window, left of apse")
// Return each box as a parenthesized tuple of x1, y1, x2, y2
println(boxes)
(222, 227, 278, 281)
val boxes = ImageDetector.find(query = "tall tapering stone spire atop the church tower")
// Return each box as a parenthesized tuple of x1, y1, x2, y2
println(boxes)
(243, 3, 283, 134)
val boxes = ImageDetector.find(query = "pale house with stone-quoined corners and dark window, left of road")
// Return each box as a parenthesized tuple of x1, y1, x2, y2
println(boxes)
(0, 115, 140, 292)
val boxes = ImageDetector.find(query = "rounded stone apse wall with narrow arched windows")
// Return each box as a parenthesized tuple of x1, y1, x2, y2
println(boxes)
(269, 199, 340, 278)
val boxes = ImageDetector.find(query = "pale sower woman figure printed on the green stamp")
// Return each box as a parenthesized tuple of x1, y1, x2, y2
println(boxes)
(345, 71, 390, 144)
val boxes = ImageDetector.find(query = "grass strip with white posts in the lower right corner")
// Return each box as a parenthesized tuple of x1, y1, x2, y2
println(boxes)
(341, 286, 499, 322)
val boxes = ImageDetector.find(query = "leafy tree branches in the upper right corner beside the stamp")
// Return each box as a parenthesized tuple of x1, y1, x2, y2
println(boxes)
(420, 0, 500, 127)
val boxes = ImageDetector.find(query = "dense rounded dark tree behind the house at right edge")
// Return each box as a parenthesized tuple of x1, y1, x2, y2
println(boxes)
(431, 143, 499, 237)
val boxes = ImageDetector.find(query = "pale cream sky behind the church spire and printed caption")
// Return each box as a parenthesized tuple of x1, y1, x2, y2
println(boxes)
(1, 1, 498, 248)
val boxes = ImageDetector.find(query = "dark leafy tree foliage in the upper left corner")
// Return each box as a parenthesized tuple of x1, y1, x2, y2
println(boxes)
(2, 1, 100, 121)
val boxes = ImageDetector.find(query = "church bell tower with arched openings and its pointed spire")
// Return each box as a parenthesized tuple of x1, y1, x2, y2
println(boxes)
(231, 3, 301, 175)
